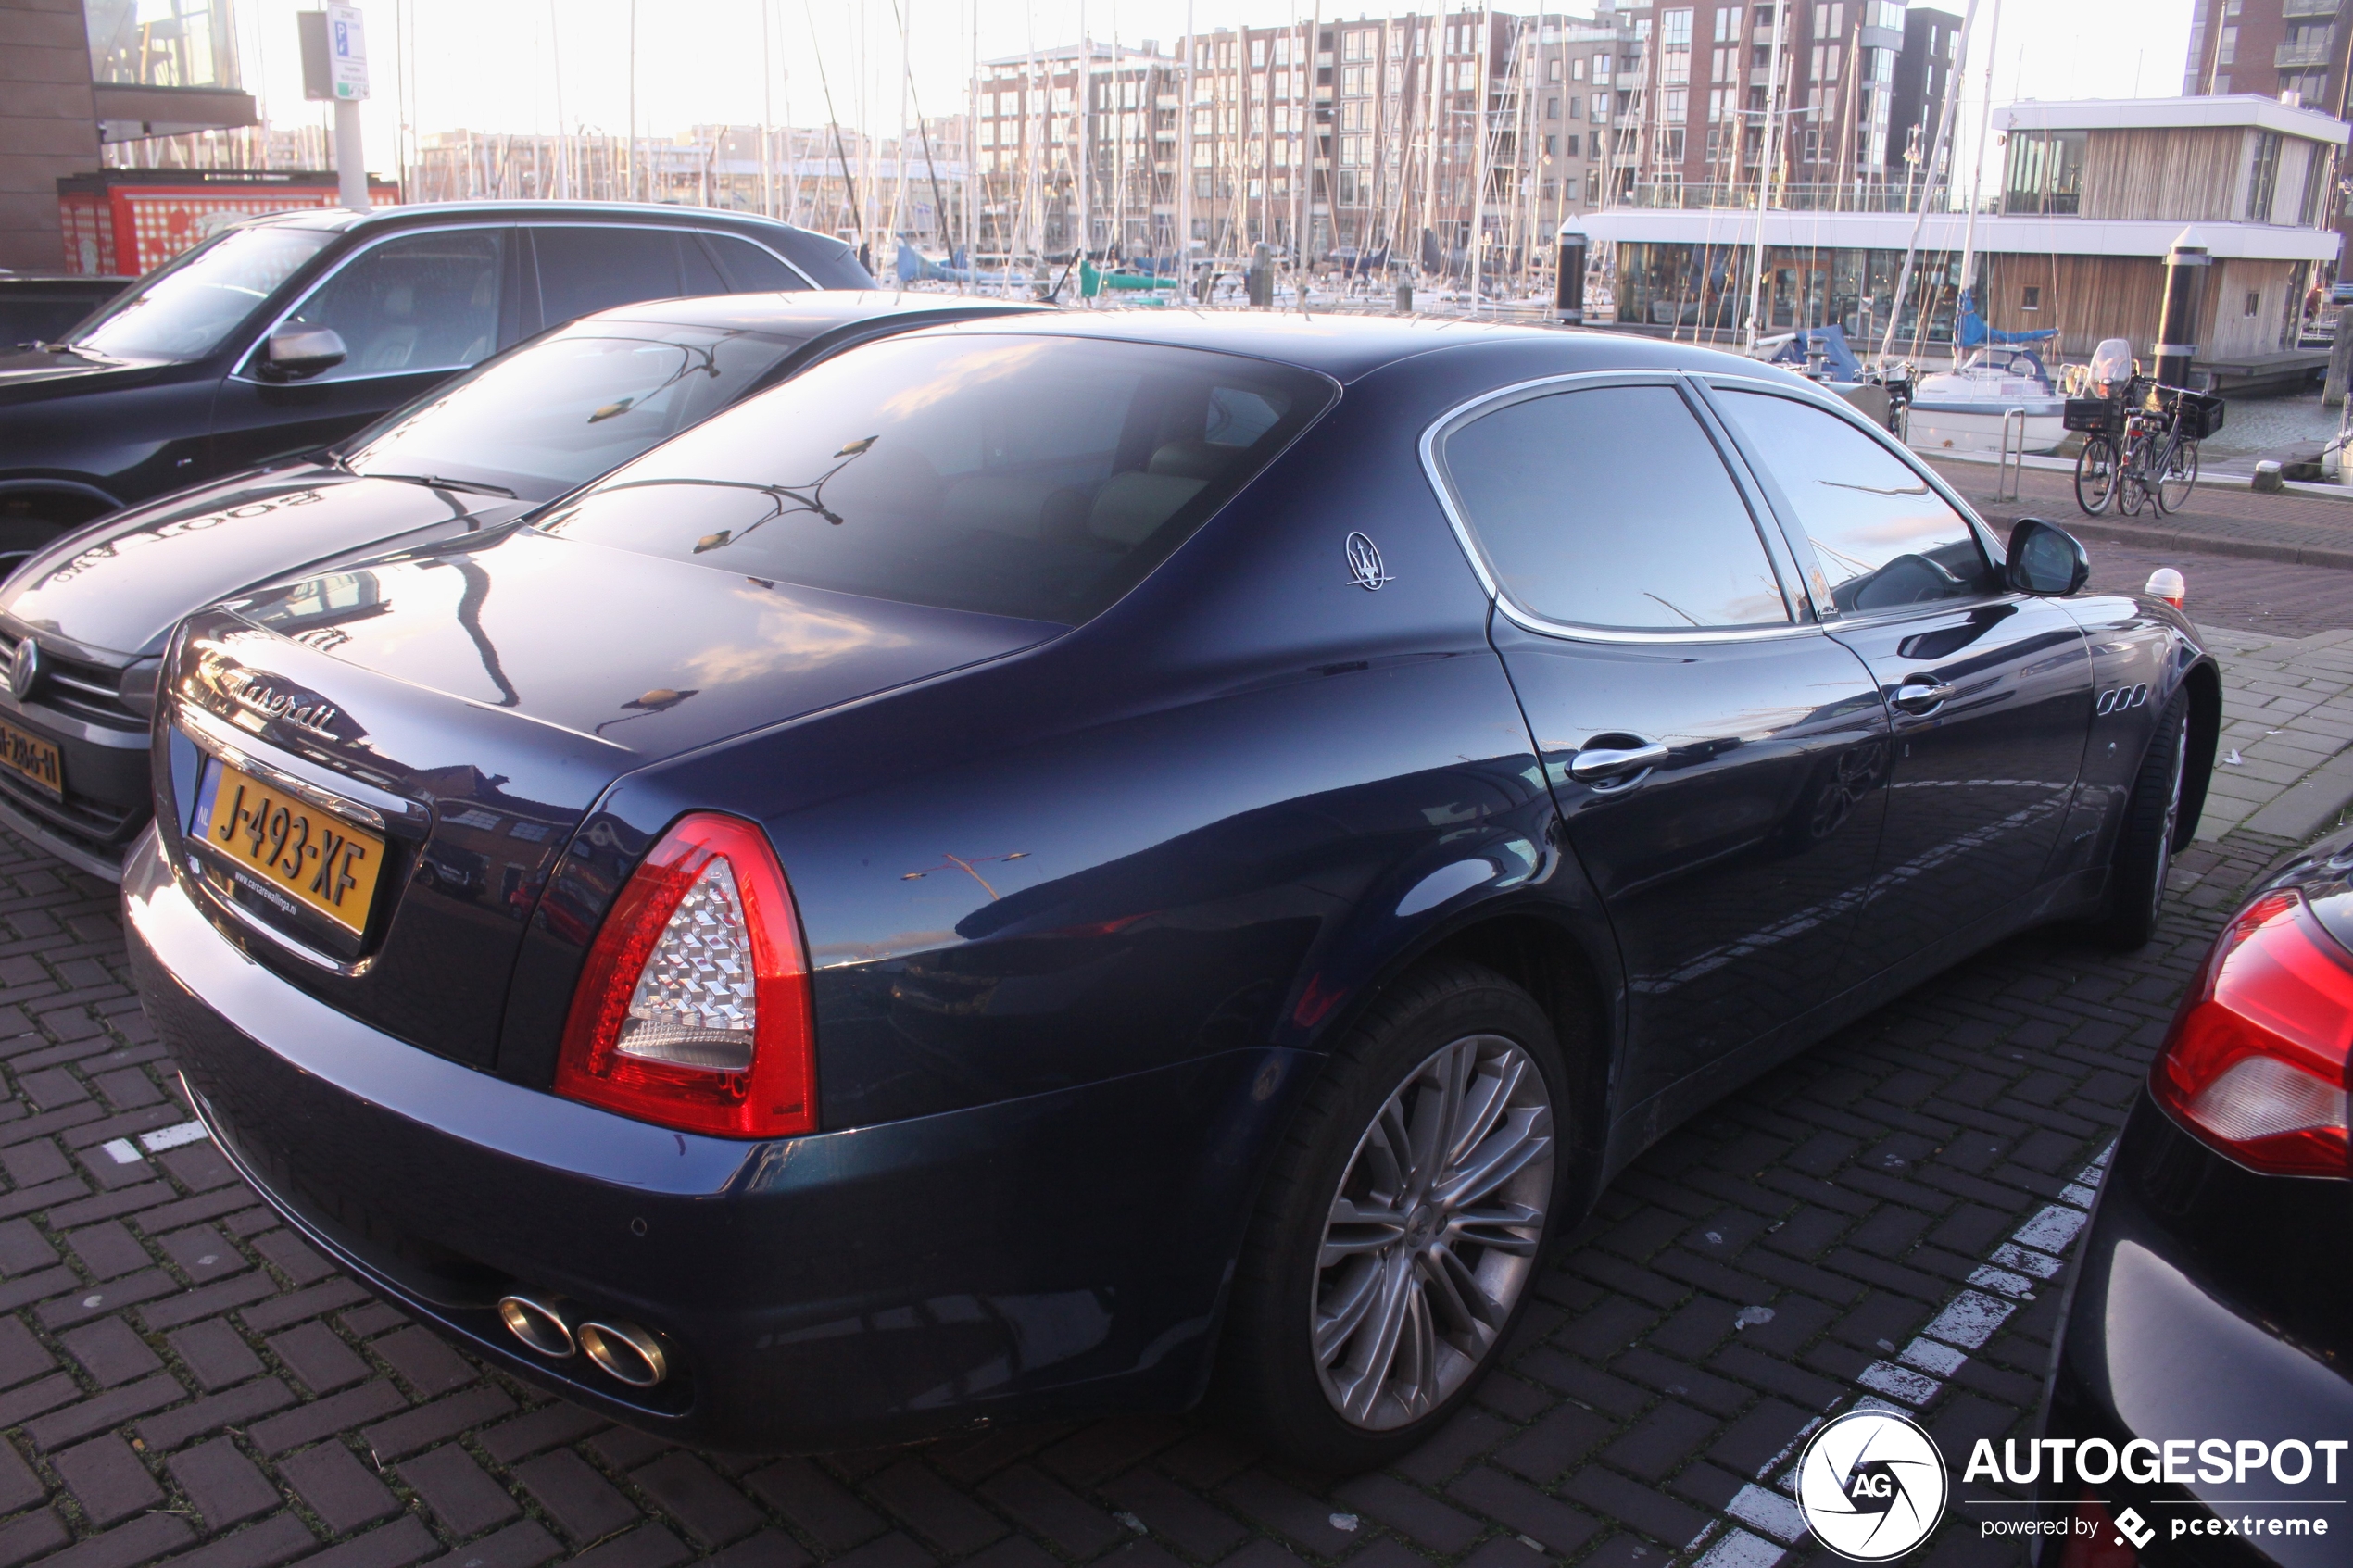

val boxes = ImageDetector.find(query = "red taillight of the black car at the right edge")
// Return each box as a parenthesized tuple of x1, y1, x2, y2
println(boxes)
(2148, 891, 2353, 1178)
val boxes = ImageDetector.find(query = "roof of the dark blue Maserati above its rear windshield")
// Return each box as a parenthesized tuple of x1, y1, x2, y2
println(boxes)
(889, 308, 1803, 383)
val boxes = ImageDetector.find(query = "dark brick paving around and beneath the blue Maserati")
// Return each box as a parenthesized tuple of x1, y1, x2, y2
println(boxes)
(0, 621, 2334, 1568)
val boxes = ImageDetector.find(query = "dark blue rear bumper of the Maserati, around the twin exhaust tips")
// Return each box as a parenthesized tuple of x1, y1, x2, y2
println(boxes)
(125, 834, 1313, 1453)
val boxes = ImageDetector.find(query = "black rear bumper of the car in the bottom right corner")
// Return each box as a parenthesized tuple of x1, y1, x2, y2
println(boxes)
(2035, 1091, 2353, 1568)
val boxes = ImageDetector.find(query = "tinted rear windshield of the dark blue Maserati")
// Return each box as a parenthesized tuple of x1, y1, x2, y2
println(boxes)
(539, 336, 1332, 625)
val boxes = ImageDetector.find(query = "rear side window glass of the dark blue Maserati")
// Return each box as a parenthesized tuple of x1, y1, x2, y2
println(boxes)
(1442, 385, 1788, 630)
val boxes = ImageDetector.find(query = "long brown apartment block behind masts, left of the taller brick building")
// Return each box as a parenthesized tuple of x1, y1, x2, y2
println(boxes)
(972, 0, 1640, 270)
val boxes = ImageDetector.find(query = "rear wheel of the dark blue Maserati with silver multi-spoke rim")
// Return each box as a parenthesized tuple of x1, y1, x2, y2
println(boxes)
(1214, 964, 1572, 1474)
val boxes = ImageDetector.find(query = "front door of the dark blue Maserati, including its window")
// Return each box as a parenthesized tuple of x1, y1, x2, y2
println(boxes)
(1713, 383, 2092, 980)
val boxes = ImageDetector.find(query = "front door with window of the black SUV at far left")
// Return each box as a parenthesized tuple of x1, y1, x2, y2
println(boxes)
(209, 228, 515, 472)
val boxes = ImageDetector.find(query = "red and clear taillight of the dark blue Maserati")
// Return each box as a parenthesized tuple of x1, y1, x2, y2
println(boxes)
(555, 811, 816, 1138)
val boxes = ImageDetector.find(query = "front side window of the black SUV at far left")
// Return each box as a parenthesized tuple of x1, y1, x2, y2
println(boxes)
(292, 228, 506, 381)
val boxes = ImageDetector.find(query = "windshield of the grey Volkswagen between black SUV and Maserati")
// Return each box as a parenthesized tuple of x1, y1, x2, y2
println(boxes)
(346, 322, 798, 501)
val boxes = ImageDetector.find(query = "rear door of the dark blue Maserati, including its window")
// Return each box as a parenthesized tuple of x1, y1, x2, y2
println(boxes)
(1430, 376, 1887, 1102)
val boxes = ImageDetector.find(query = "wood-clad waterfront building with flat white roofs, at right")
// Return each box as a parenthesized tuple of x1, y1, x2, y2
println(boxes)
(1586, 96, 2348, 362)
